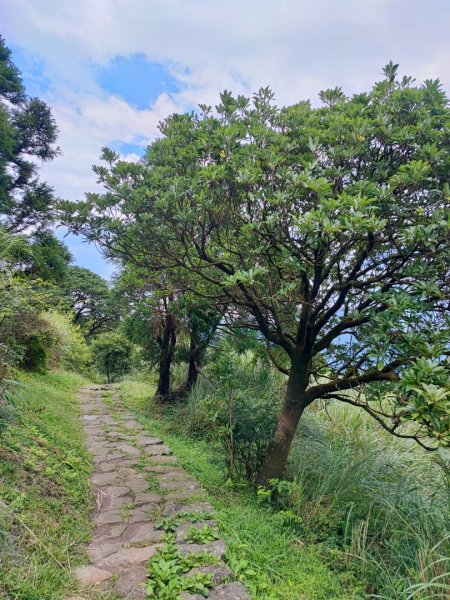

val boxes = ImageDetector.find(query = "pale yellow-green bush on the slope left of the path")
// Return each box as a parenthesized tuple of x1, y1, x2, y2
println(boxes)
(44, 311, 91, 374)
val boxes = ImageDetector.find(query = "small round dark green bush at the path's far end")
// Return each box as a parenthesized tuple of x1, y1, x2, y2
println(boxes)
(91, 332, 133, 383)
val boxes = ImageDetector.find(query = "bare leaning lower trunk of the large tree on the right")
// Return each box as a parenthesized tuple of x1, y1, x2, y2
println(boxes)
(256, 356, 308, 486)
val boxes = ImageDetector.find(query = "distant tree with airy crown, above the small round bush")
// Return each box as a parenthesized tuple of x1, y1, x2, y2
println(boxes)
(61, 266, 118, 336)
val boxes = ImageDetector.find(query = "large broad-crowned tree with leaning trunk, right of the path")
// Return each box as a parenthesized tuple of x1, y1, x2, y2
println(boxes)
(64, 63, 450, 483)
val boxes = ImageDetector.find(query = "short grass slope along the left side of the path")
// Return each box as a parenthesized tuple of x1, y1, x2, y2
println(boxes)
(0, 372, 91, 600)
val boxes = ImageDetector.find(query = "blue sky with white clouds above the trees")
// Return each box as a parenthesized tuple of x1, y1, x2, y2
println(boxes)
(0, 0, 450, 278)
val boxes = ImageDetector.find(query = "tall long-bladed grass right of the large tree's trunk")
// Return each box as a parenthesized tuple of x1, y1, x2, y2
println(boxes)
(289, 404, 450, 600)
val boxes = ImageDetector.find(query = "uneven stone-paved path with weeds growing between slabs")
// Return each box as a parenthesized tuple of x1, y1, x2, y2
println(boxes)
(66, 386, 249, 600)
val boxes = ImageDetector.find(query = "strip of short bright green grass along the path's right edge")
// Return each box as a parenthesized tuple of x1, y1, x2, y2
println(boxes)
(121, 380, 366, 600)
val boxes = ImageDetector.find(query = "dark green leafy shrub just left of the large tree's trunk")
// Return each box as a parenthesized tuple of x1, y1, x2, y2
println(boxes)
(175, 343, 285, 481)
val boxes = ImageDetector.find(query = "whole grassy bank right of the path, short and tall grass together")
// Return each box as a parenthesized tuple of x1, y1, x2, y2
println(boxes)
(122, 381, 450, 600)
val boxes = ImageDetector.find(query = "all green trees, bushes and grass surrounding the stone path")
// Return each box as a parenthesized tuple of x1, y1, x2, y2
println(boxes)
(0, 32, 450, 600)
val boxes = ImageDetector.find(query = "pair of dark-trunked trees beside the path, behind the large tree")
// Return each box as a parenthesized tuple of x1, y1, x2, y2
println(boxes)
(116, 261, 223, 401)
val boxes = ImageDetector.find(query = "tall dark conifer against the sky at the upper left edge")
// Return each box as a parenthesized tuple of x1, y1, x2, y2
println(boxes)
(0, 36, 59, 232)
